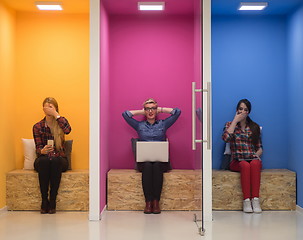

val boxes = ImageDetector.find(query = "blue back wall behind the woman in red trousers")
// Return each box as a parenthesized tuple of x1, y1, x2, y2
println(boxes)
(212, 16, 289, 169)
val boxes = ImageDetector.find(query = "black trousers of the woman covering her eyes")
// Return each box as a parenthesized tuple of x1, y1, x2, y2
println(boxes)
(34, 155, 68, 201)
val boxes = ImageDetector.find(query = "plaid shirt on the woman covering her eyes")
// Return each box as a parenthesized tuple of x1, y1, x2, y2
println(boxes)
(33, 117, 72, 158)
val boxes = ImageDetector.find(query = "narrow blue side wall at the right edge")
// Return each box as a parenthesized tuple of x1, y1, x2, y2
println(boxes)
(288, 6, 303, 207)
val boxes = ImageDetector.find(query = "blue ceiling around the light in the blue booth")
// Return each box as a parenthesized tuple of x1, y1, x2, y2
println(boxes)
(211, 0, 303, 15)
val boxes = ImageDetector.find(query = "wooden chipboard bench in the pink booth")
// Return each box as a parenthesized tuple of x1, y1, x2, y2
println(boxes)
(107, 169, 201, 210)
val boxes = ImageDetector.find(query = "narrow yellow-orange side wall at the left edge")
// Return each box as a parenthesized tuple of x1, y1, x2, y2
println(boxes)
(0, 3, 15, 209)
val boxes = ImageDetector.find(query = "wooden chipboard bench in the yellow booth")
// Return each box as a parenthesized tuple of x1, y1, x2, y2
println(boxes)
(6, 169, 89, 211)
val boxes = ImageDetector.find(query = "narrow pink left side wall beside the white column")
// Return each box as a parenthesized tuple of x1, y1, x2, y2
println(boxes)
(100, 2, 109, 210)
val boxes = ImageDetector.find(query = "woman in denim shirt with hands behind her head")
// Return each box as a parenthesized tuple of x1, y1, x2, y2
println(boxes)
(122, 98, 181, 214)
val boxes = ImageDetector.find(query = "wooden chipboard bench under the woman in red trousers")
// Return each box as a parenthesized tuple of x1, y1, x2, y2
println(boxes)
(212, 169, 296, 210)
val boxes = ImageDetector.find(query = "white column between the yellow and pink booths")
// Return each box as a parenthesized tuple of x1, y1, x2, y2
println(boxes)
(89, 0, 100, 221)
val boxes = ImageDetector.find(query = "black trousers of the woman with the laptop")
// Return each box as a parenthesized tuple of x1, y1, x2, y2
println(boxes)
(142, 162, 163, 201)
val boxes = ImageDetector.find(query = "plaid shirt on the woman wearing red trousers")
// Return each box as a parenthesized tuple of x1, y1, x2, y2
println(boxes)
(222, 122, 262, 160)
